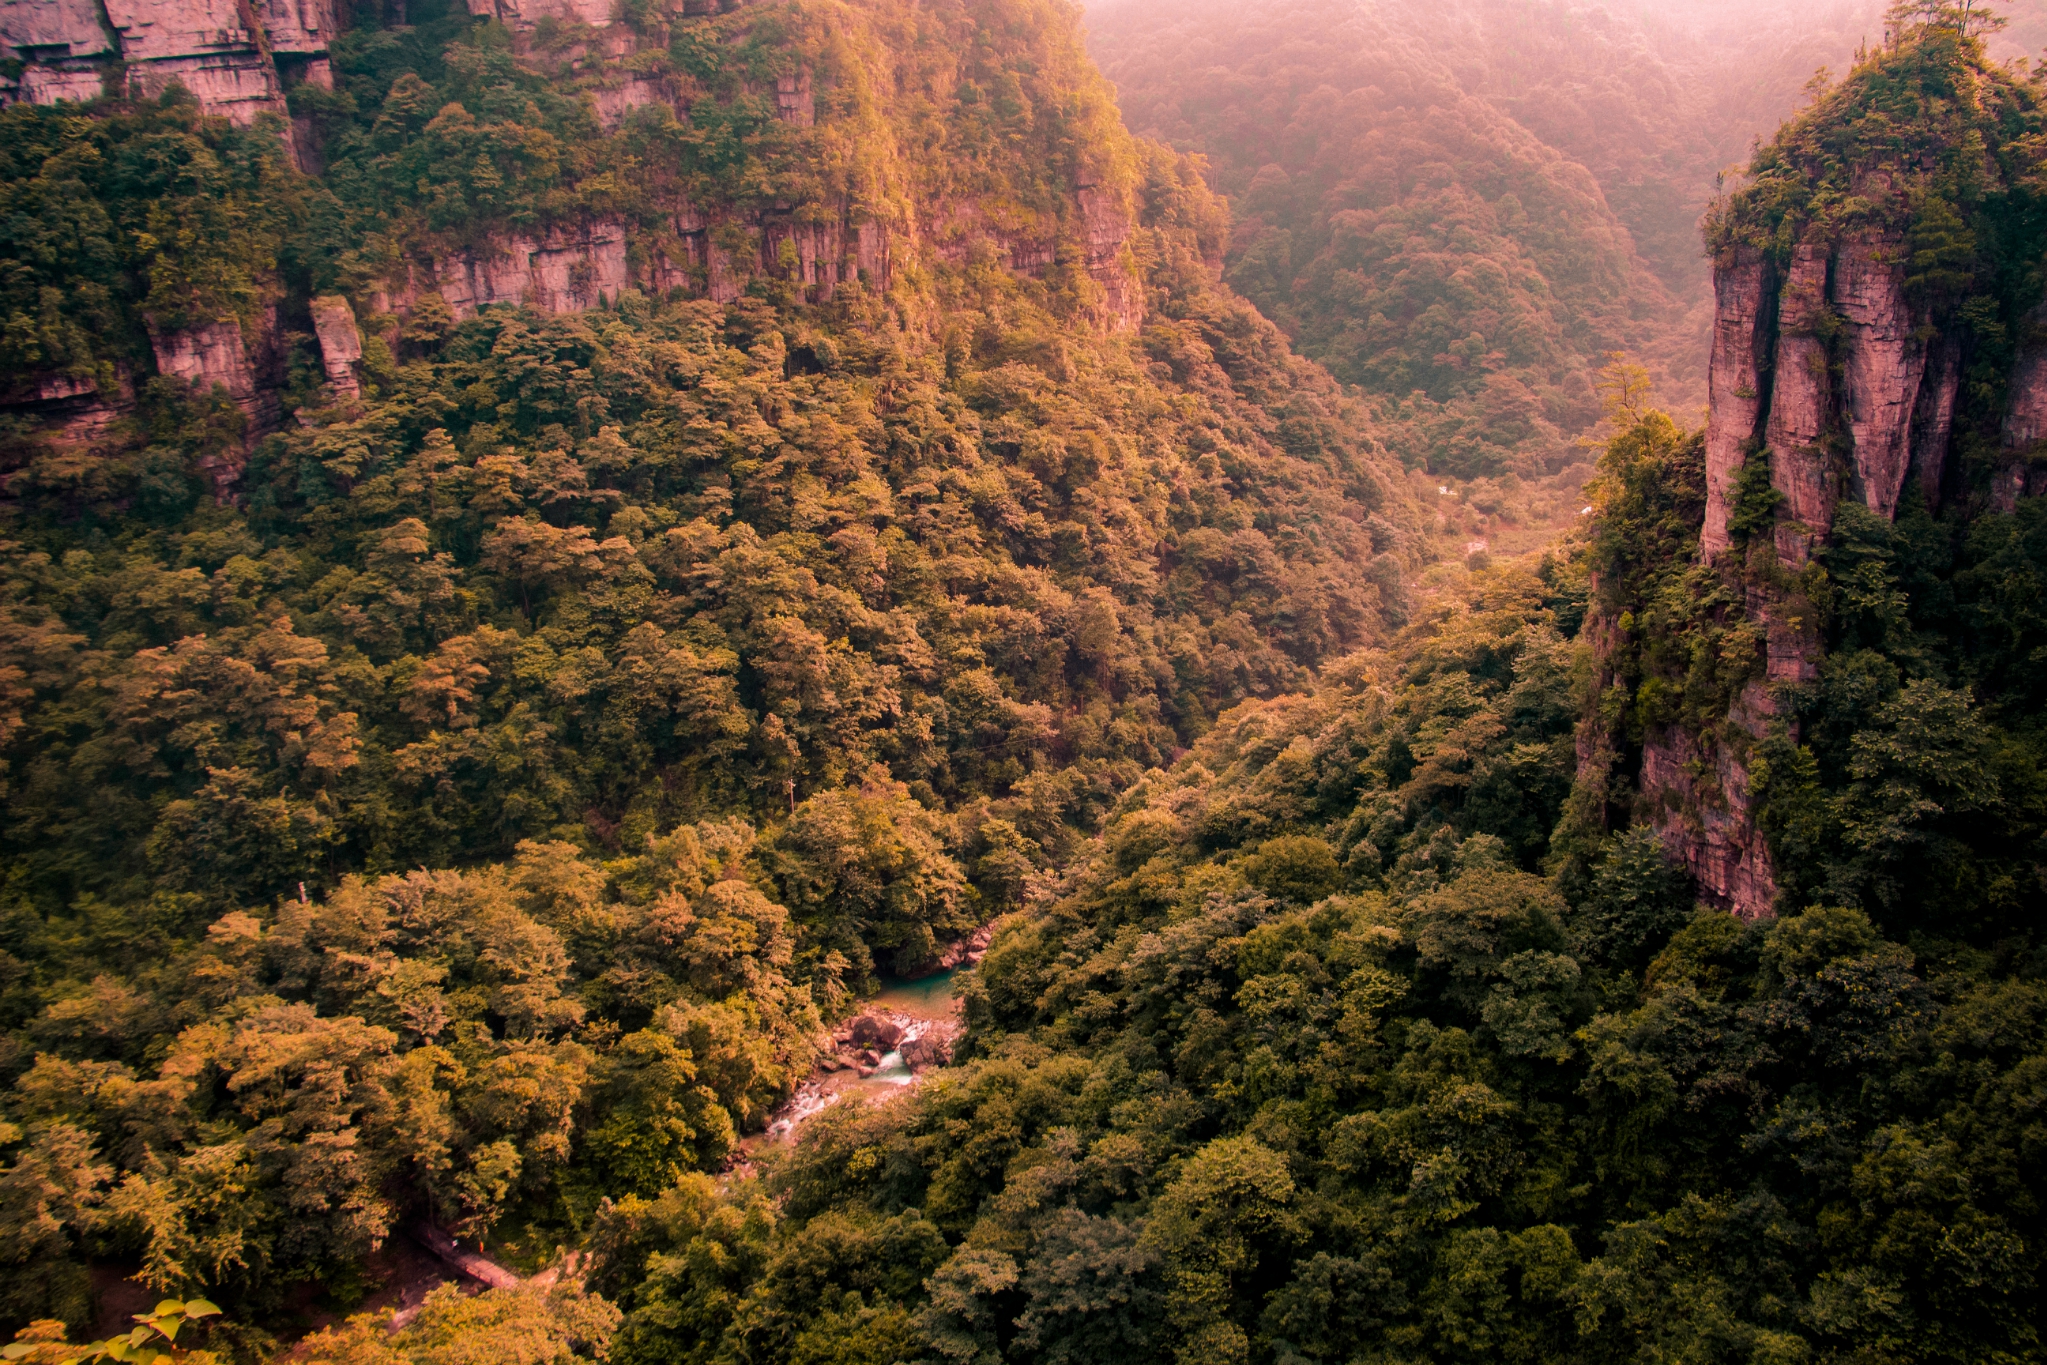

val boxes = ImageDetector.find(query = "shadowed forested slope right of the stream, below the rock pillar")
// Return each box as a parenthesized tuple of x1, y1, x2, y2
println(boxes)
(577, 376, 2047, 1363)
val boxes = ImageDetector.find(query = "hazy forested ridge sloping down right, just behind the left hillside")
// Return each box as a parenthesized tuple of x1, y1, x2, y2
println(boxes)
(1091, 0, 1699, 479)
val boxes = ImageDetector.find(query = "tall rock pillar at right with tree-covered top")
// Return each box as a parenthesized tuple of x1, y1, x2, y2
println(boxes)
(1640, 31, 2047, 917)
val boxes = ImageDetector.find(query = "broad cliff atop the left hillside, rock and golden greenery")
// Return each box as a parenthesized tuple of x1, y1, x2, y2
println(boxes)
(0, 0, 1144, 495)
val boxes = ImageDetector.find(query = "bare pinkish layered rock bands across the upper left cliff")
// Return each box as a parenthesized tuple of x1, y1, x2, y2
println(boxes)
(0, 0, 1144, 497)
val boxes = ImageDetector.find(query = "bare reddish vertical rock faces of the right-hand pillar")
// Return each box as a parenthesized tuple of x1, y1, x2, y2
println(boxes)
(1653, 202, 2047, 917)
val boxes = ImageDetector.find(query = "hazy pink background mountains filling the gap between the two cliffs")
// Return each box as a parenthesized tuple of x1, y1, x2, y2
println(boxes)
(1089, 0, 2029, 479)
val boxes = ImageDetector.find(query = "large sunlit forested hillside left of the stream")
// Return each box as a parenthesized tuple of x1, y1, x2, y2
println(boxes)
(0, 2, 1429, 1340)
